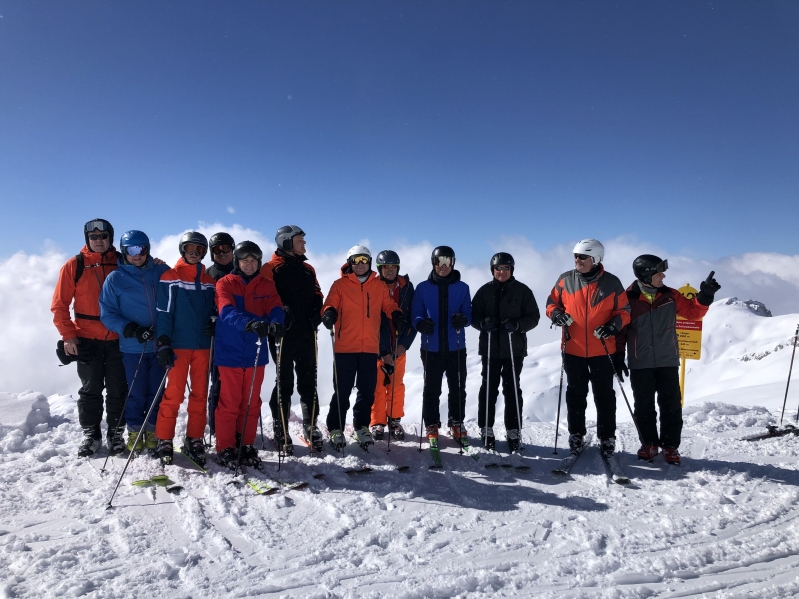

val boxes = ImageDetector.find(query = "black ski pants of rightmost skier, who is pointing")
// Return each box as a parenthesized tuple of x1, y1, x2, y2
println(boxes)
(630, 366, 682, 448)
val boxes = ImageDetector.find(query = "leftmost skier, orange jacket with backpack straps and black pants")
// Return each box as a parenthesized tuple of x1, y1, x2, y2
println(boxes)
(50, 218, 128, 457)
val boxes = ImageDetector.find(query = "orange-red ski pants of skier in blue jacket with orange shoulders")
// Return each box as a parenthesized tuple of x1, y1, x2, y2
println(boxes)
(155, 349, 211, 439)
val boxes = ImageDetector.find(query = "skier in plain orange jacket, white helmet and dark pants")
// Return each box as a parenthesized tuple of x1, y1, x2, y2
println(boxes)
(322, 245, 406, 450)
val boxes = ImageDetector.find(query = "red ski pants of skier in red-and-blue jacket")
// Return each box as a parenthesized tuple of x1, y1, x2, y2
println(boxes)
(216, 366, 264, 453)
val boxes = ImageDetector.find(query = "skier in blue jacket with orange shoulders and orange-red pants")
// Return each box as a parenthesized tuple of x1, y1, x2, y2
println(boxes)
(155, 231, 216, 466)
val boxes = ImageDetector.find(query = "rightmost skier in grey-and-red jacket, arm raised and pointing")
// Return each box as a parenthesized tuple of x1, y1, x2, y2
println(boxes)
(616, 254, 721, 464)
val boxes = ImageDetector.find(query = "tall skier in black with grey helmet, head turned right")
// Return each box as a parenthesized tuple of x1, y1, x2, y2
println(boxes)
(261, 225, 324, 454)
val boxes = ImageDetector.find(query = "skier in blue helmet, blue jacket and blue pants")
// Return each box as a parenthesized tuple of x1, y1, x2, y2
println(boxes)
(100, 231, 169, 451)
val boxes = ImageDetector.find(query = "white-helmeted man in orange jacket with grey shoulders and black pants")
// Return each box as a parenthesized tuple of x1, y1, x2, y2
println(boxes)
(546, 239, 630, 458)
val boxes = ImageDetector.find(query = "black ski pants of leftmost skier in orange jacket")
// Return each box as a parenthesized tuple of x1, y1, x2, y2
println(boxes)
(78, 338, 128, 430)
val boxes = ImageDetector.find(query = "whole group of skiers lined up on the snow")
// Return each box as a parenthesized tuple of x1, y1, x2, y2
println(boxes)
(52, 219, 719, 468)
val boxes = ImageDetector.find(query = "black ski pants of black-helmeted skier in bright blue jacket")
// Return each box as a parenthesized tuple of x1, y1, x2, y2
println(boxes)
(421, 349, 466, 427)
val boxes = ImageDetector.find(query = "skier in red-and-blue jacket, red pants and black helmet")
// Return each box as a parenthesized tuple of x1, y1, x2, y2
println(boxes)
(214, 241, 285, 469)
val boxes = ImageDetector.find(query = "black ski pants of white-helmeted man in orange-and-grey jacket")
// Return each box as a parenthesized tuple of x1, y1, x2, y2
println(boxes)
(563, 354, 616, 439)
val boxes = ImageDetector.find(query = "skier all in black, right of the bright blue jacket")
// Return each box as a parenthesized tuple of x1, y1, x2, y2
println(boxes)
(472, 252, 541, 452)
